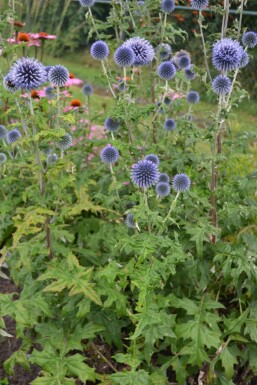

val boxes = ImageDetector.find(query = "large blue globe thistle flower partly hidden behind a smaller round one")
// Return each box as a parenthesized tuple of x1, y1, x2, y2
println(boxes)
(122, 37, 154, 66)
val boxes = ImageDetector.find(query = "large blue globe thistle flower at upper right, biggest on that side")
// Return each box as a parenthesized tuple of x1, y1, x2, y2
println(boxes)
(212, 38, 243, 71)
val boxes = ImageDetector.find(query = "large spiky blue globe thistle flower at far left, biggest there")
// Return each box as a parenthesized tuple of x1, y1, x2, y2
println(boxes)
(10, 58, 47, 91)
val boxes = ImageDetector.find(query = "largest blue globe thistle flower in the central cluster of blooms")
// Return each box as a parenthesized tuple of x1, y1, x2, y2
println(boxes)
(131, 159, 159, 189)
